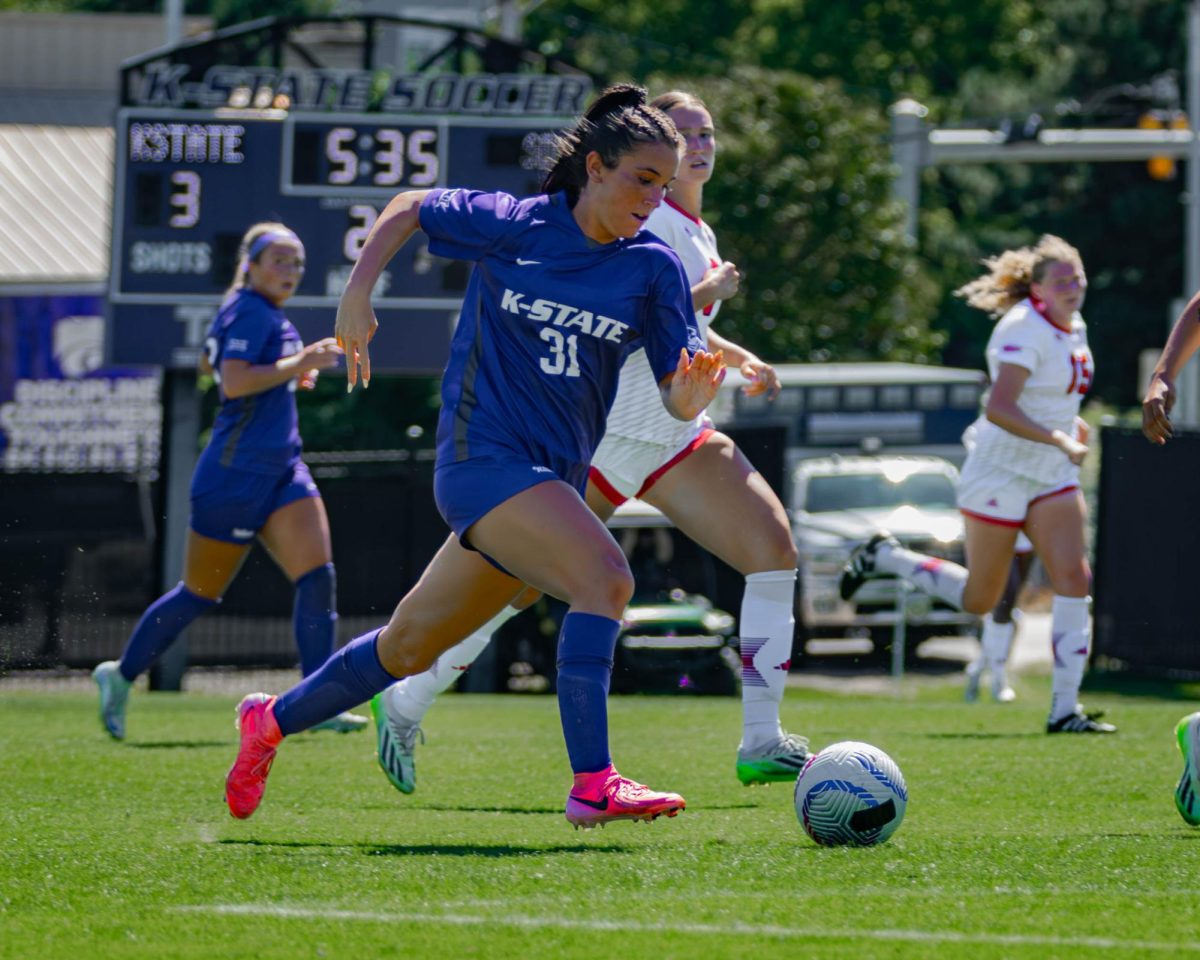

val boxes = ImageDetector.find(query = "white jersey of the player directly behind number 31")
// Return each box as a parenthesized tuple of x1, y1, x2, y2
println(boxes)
(593, 199, 721, 446)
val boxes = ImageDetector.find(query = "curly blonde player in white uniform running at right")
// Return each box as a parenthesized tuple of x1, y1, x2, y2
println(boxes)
(841, 235, 1116, 733)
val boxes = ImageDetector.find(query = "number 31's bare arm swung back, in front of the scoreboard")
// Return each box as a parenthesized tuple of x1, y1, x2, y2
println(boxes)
(334, 190, 428, 392)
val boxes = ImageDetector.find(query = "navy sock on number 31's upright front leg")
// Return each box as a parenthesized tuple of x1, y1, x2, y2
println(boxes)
(558, 613, 620, 773)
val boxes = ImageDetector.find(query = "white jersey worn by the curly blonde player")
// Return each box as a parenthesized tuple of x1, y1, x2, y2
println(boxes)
(968, 299, 1093, 484)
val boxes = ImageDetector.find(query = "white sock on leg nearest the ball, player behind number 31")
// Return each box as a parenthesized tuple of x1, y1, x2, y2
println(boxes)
(738, 569, 796, 749)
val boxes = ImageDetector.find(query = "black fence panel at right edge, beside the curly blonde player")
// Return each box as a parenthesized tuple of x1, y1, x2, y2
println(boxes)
(1093, 427, 1200, 678)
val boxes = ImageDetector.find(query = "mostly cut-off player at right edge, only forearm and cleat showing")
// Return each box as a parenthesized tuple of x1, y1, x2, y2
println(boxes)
(1141, 293, 1200, 827)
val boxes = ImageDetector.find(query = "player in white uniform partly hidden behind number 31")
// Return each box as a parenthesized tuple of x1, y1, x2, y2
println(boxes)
(372, 92, 809, 793)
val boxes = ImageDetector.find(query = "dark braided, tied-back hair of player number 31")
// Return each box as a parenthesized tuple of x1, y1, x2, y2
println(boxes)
(541, 83, 680, 206)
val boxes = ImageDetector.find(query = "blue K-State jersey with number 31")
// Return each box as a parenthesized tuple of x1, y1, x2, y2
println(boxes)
(420, 190, 703, 475)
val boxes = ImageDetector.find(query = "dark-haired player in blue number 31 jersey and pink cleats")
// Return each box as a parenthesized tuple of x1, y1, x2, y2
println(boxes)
(226, 86, 725, 827)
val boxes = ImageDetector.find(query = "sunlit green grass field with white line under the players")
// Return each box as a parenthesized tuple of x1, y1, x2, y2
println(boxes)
(0, 678, 1200, 960)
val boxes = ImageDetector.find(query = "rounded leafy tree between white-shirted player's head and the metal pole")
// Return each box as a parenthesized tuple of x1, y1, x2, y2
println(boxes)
(653, 67, 940, 362)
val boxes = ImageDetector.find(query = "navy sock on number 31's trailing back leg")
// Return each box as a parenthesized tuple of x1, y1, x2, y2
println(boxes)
(272, 628, 400, 737)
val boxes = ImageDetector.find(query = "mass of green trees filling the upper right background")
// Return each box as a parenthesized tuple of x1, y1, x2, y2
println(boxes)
(528, 0, 1187, 404)
